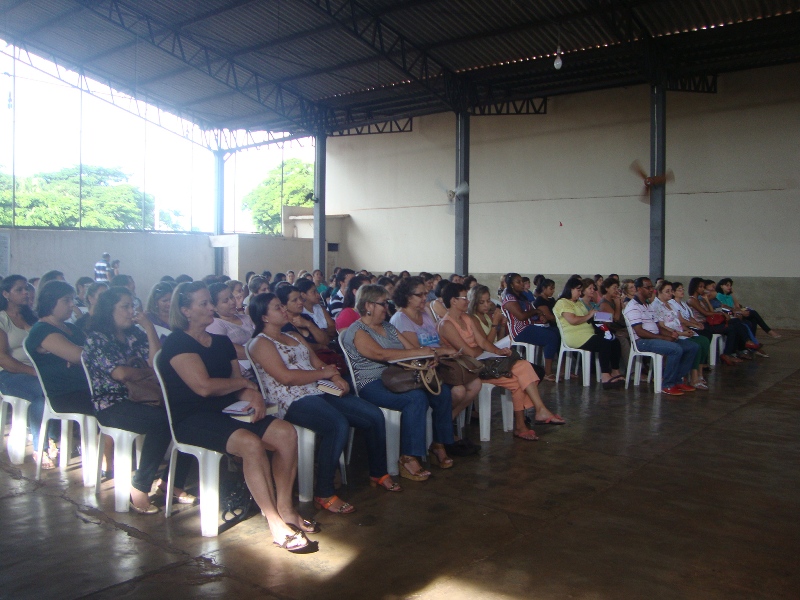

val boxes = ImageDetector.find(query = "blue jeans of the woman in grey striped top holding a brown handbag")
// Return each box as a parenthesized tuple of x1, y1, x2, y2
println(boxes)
(361, 379, 453, 456)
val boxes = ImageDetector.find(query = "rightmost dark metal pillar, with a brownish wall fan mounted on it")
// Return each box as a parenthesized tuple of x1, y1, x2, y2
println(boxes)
(650, 83, 667, 281)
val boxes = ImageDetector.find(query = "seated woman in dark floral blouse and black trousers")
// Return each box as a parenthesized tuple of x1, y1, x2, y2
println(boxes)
(83, 287, 196, 515)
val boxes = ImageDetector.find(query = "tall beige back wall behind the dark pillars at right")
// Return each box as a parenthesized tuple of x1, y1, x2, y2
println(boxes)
(327, 65, 800, 277)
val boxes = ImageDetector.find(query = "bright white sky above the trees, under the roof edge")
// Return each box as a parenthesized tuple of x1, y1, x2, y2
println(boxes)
(0, 40, 314, 232)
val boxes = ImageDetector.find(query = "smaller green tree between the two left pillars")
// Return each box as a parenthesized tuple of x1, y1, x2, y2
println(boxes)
(242, 158, 314, 234)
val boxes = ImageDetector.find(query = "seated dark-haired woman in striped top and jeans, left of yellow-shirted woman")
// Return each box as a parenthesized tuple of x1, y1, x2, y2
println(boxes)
(501, 273, 561, 381)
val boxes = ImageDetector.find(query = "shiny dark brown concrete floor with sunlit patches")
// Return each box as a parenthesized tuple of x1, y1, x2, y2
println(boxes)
(0, 332, 800, 600)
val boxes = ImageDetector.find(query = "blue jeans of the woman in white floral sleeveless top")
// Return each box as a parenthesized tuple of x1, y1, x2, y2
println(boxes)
(284, 394, 386, 498)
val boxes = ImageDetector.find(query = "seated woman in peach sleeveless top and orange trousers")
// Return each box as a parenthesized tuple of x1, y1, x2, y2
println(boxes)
(439, 283, 565, 441)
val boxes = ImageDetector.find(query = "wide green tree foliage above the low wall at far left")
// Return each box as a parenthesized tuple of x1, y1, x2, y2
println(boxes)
(0, 165, 181, 231)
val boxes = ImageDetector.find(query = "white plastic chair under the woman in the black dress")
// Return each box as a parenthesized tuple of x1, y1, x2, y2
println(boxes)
(153, 350, 223, 537)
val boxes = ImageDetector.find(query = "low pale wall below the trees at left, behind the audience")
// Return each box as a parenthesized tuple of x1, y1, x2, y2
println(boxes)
(0, 229, 214, 301)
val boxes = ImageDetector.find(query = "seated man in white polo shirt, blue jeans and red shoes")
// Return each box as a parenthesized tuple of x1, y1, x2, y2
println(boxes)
(623, 277, 699, 396)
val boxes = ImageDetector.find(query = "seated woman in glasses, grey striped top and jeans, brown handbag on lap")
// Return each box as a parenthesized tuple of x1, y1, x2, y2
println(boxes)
(340, 285, 453, 481)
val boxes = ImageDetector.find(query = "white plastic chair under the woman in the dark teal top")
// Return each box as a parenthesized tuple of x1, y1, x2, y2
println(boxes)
(22, 339, 97, 487)
